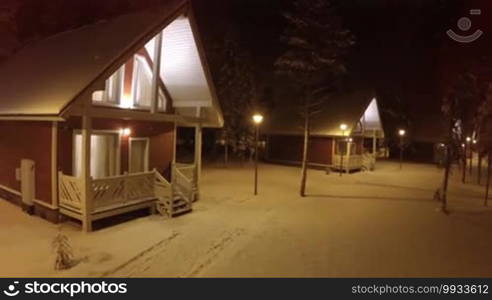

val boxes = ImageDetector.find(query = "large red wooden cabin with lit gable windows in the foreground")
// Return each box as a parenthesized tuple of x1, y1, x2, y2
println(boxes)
(0, 0, 223, 231)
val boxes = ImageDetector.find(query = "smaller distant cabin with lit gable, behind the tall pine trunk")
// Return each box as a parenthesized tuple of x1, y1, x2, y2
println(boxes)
(262, 91, 387, 172)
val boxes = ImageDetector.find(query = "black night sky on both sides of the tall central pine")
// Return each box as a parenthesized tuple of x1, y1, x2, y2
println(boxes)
(195, 0, 492, 141)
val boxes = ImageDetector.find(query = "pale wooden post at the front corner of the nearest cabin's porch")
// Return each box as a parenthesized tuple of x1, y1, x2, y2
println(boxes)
(81, 111, 93, 232)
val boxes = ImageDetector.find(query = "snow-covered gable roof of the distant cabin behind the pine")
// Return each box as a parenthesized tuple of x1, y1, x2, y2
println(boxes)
(263, 91, 383, 136)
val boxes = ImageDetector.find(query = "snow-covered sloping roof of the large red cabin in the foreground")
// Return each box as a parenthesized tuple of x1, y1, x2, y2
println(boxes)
(0, 0, 222, 124)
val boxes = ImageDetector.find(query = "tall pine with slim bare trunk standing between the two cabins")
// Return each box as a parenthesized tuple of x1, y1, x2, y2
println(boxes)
(275, 0, 355, 197)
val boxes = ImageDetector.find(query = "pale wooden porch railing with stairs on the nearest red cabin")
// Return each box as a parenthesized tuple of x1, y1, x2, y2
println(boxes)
(59, 165, 197, 226)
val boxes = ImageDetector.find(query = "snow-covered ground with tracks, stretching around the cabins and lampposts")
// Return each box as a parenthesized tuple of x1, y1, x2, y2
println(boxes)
(0, 162, 492, 277)
